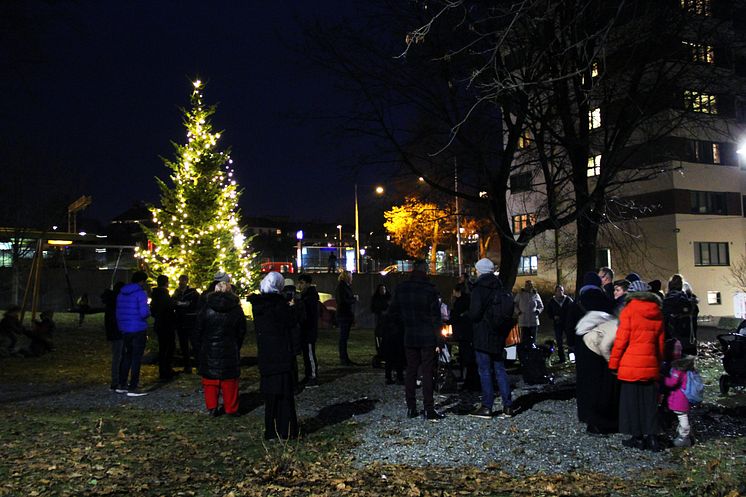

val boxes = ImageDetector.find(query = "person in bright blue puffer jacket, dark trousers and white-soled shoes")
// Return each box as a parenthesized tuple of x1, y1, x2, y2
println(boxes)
(116, 271, 150, 397)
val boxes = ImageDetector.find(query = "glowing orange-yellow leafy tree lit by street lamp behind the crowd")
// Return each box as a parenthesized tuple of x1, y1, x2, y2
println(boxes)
(383, 196, 452, 272)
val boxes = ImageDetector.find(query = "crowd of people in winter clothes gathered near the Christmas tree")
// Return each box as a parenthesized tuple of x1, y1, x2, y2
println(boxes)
(0, 258, 698, 451)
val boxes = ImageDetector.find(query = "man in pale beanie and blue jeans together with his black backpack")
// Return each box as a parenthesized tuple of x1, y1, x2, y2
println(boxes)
(469, 258, 515, 419)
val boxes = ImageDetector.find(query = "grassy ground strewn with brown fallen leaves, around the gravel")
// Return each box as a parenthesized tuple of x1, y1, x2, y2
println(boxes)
(0, 315, 746, 497)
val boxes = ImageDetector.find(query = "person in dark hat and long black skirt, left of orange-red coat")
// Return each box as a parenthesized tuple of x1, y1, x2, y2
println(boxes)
(567, 271, 619, 434)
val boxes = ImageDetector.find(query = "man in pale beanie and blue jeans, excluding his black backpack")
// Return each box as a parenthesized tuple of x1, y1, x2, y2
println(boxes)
(469, 258, 515, 419)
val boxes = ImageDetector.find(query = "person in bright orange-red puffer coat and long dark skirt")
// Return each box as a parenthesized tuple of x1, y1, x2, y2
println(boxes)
(609, 281, 664, 452)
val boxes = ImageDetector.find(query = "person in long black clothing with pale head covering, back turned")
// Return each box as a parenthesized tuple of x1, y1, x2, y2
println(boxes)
(249, 271, 298, 440)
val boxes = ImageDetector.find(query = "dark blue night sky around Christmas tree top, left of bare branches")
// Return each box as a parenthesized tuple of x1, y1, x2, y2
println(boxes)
(0, 0, 390, 226)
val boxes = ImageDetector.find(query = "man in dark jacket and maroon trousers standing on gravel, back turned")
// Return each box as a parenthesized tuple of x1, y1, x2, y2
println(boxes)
(388, 260, 444, 421)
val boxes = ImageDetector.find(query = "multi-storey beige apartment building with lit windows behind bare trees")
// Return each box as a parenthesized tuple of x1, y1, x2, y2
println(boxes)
(509, 0, 746, 317)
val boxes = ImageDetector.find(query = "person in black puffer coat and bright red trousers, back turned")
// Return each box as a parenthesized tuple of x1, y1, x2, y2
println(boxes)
(194, 281, 246, 416)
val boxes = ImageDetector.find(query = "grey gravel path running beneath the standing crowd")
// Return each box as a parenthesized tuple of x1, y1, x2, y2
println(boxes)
(0, 346, 746, 477)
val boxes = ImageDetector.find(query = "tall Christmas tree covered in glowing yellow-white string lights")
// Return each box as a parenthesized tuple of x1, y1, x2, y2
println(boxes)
(136, 80, 255, 294)
